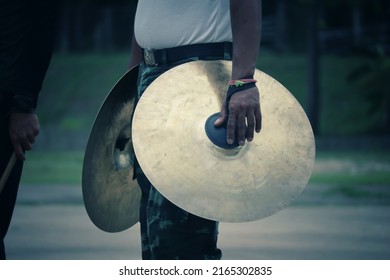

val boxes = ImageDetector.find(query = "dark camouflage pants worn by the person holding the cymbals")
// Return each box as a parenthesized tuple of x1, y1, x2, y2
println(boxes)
(135, 57, 222, 260)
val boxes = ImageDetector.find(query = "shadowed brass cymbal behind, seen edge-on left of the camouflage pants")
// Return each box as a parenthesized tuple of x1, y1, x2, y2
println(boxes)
(82, 67, 141, 232)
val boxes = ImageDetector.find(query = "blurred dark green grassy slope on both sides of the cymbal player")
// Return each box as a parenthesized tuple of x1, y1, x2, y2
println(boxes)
(38, 51, 384, 146)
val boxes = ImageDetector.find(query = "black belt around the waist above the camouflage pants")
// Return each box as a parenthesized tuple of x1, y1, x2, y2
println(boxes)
(143, 42, 233, 65)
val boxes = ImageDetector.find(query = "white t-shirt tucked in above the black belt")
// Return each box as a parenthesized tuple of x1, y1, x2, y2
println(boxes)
(134, 0, 232, 49)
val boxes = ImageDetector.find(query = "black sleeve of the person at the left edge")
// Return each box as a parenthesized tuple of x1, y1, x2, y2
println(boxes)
(0, 0, 57, 107)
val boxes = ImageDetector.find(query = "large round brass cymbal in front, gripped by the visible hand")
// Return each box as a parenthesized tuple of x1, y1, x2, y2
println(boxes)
(132, 61, 315, 222)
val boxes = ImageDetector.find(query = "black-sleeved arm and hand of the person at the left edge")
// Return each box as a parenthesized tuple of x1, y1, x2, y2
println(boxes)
(0, 0, 56, 160)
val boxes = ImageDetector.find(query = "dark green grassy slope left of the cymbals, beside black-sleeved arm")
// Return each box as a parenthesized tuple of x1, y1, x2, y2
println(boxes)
(38, 51, 128, 130)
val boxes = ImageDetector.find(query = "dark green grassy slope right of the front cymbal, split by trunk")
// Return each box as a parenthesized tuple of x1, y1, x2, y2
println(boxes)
(258, 53, 378, 136)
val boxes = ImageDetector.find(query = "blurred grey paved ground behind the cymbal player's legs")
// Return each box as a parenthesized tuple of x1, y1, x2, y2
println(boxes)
(6, 186, 390, 260)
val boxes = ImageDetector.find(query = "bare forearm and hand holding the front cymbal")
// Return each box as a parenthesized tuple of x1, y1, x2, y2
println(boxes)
(215, 0, 261, 145)
